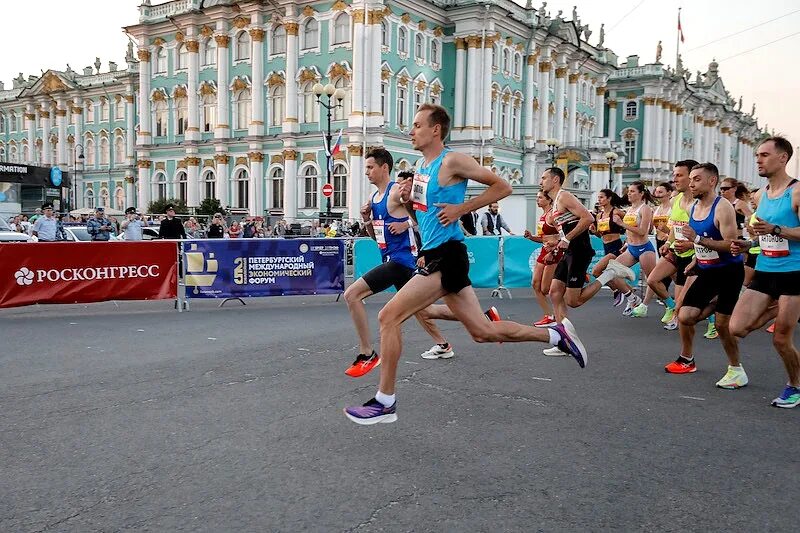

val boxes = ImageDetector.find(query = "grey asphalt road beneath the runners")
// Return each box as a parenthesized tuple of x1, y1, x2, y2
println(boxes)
(0, 290, 800, 532)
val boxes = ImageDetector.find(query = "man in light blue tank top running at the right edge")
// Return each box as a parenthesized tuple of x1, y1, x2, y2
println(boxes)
(732, 137, 800, 408)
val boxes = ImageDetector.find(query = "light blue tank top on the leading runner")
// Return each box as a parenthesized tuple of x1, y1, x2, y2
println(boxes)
(412, 148, 467, 250)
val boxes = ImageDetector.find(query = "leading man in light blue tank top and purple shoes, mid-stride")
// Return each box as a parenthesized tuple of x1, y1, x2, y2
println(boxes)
(344, 104, 587, 424)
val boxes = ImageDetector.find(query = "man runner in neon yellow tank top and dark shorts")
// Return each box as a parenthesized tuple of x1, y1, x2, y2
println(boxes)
(647, 159, 697, 330)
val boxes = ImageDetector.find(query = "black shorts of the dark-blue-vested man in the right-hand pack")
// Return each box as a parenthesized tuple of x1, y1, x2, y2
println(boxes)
(683, 263, 744, 315)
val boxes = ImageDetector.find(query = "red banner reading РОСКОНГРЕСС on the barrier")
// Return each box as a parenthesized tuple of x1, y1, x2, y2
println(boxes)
(0, 242, 178, 308)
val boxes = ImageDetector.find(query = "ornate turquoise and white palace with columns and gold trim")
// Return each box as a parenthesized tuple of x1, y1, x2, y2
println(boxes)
(0, 0, 763, 226)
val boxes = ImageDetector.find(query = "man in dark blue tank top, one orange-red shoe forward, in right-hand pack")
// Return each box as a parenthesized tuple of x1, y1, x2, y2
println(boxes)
(664, 163, 747, 389)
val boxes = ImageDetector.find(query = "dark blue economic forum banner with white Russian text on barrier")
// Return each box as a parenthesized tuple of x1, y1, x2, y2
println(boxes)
(183, 239, 344, 298)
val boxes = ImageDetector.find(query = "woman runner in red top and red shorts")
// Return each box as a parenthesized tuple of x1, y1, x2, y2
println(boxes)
(523, 191, 560, 328)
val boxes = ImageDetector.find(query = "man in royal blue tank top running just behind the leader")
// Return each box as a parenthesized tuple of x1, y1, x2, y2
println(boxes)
(344, 148, 454, 378)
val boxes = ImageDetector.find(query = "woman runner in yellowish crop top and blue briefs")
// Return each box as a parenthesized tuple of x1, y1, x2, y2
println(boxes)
(614, 181, 656, 318)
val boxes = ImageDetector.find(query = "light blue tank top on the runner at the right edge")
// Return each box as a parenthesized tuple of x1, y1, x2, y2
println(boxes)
(756, 180, 800, 272)
